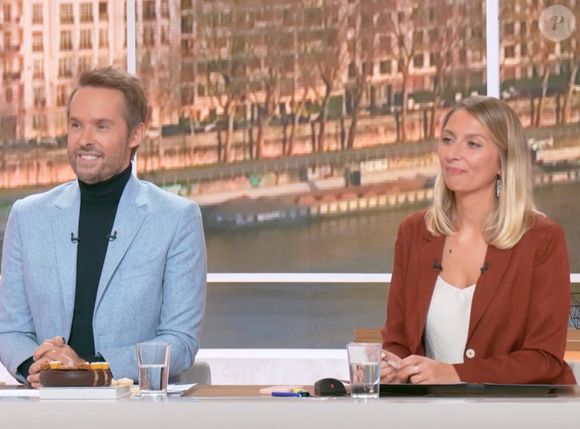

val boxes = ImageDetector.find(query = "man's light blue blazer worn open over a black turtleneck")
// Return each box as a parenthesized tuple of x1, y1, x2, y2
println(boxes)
(0, 176, 206, 381)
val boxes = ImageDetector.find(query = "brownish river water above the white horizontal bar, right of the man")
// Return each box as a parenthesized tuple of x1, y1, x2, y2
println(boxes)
(206, 183, 580, 273)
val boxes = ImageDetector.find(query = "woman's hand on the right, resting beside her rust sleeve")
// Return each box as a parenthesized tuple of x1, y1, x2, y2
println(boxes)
(396, 355, 461, 384)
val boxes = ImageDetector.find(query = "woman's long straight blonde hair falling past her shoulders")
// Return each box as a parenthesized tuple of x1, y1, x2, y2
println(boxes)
(425, 96, 537, 249)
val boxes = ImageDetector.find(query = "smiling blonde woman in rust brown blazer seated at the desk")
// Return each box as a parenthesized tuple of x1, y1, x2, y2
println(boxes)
(381, 97, 575, 384)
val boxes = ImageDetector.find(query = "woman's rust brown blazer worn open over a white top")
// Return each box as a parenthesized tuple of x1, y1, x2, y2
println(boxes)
(382, 212, 575, 384)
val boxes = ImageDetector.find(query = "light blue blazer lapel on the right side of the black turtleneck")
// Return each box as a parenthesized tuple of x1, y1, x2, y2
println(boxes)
(95, 175, 147, 312)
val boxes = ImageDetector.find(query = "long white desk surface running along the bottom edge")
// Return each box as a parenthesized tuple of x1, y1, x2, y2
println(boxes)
(0, 388, 580, 429)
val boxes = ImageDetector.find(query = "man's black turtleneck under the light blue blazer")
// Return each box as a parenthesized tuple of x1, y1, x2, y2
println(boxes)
(68, 164, 131, 361)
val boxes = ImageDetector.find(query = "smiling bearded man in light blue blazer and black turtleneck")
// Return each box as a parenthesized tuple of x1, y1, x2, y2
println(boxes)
(0, 67, 206, 387)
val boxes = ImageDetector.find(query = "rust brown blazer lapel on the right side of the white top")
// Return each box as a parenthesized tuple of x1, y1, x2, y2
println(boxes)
(467, 246, 513, 341)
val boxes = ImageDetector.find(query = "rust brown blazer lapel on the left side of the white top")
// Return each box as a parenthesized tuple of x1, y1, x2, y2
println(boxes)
(411, 231, 445, 347)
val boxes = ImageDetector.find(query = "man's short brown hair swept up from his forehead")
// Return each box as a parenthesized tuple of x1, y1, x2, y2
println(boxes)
(66, 67, 150, 155)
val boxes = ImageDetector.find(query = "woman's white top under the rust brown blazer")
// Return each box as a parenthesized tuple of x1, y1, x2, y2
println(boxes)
(424, 276, 475, 364)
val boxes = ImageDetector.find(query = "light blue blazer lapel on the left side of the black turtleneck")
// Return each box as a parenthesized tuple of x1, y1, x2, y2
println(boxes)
(49, 182, 81, 329)
